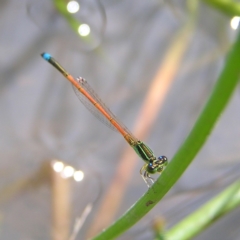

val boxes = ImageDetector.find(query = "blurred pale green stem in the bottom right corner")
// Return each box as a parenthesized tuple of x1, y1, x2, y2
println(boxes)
(165, 181, 240, 240)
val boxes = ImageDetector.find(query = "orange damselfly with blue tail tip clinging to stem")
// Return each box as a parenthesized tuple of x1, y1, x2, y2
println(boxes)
(41, 53, 168, 186)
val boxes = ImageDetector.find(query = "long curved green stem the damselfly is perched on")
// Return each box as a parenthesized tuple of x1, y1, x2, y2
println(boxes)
(93, 29, 240, 240)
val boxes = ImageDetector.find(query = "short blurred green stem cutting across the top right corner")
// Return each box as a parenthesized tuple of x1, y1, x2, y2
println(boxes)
(203, 0, 240, 17)
